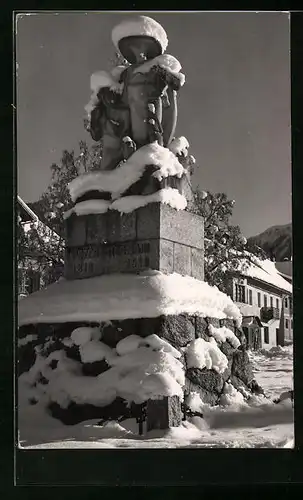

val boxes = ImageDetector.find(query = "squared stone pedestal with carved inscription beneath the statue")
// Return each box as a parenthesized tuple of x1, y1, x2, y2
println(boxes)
(65, 203, 204, 280)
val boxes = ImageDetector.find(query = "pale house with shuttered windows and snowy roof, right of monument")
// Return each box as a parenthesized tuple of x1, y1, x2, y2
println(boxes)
(227, 260, 293, 349)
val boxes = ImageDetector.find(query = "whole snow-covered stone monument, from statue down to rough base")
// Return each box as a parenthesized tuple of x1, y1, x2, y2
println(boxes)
(19, 16, 260, 430)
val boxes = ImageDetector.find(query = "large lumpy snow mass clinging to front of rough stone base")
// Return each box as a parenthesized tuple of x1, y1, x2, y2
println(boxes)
(19, 328, 185, 408)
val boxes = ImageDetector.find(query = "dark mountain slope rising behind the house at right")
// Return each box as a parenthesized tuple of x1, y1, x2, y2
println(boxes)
(248, 224, 292, 262)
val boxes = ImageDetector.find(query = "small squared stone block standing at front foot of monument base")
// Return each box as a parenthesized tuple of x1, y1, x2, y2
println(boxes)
(146, 396, 182, 431)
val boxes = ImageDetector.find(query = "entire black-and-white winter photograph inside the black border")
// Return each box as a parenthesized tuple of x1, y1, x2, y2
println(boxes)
(15, 11, 294, 449)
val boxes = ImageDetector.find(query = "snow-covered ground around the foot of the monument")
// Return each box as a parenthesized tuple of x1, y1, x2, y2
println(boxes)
(20, 346, 294, 449)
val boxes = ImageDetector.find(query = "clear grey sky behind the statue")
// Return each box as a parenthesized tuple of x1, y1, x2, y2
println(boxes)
(16, 12, 291, 236)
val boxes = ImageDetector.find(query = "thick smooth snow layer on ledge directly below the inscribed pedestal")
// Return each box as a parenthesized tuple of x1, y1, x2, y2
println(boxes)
(19, 271, 241, 326)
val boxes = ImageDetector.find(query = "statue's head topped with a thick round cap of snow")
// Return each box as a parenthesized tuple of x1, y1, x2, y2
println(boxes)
(112, 16, 168, 64)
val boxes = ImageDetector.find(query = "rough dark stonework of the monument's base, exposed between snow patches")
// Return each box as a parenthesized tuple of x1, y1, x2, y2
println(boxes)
(18, 314, 260, 431)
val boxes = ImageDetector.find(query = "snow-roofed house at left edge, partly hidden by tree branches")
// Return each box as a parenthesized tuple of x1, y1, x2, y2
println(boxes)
(17, 196, 63, 299)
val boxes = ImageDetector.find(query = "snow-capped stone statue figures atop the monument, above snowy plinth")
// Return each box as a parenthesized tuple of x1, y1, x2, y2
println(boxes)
(87, 16, 184, 170)
